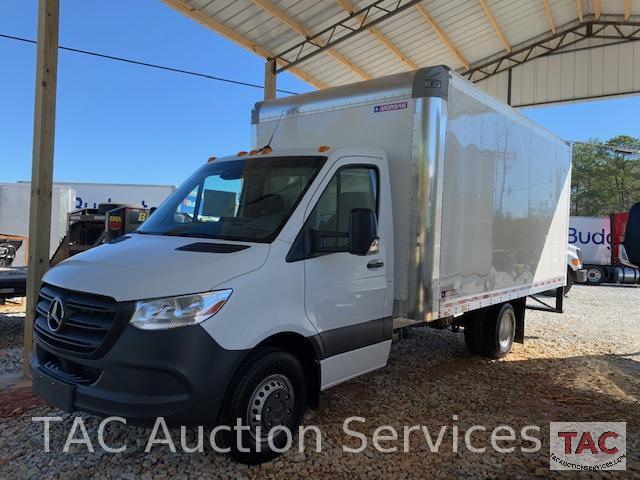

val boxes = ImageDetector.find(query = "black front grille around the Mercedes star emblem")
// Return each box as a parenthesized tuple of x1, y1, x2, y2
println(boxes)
(34, 285, 118, 354)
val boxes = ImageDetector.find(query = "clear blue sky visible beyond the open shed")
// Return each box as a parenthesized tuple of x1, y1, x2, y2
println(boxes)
(0, 0, 640, 185)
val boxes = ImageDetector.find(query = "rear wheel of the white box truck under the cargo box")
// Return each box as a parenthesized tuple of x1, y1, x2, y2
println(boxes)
(480, 303, 516, 358)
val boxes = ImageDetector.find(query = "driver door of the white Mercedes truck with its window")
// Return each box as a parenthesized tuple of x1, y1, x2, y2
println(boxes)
(304, 157, 391, 389)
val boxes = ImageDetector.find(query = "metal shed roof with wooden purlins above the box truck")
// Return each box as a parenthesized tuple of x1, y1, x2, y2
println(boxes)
(163, 0, 640, 106)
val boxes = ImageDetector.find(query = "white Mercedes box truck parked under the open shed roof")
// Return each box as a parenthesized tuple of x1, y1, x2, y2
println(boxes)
(30, 66, 571, 463)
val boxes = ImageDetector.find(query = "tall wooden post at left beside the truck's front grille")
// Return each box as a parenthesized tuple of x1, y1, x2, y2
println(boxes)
(22, 0, 60, 378)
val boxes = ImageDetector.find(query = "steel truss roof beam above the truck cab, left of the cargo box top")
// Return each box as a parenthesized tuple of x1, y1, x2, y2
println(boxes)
(272, 0, 422, 73)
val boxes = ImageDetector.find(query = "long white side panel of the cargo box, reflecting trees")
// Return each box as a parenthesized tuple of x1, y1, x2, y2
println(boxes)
(440, 77, 571, 316)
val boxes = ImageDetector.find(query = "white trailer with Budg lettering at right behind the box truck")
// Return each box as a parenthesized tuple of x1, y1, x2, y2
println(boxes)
(569, 212, 640, 285)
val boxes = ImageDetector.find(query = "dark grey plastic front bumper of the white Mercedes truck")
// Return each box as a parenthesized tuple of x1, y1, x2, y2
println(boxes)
(29, 325, 246, 425)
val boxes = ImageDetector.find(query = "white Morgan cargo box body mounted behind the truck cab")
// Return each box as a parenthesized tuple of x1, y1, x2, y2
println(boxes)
(253, 67, 571, 320)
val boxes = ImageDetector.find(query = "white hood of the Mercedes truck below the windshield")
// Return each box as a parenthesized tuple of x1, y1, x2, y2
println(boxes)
(43, 234, 269, 301)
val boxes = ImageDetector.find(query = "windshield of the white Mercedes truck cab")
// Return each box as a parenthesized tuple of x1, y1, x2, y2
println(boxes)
(138, 157, 326, 242)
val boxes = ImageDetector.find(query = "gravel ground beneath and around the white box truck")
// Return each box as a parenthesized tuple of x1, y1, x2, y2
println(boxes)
(0, 286, 640, 479)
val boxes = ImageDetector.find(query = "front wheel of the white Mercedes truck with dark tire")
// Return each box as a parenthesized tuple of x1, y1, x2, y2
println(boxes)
(222, 348, 306, 465)
